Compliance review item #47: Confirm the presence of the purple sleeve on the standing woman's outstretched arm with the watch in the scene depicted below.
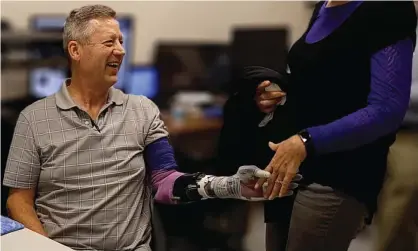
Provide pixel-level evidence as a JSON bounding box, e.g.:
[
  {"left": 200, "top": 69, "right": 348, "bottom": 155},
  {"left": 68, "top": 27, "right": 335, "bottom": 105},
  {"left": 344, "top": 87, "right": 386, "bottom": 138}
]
[{"left": 307, "top": 39, "right": 413, "bottom": 154}]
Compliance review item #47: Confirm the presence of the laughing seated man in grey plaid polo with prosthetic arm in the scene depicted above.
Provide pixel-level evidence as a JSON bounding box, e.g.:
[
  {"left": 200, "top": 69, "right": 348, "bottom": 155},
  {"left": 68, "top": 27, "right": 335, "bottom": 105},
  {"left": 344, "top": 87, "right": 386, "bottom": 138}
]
[{"left": 0, "top": 5, "right": 298, "bottom": 251}]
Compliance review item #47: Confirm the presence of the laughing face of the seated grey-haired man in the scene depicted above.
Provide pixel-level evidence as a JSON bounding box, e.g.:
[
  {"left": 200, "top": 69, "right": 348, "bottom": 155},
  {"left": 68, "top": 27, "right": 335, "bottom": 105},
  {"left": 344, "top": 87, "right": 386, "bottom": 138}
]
[{"left": 79, "top": 19, "right": 125, "bottom": 87}]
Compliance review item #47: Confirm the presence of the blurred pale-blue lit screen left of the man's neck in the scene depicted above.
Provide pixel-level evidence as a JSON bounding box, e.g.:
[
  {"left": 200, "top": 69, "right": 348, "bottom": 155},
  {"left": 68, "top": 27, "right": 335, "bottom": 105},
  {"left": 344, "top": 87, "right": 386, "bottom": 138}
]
[{"left": 29, "top": 67, "right": 67, "bottom": 99}]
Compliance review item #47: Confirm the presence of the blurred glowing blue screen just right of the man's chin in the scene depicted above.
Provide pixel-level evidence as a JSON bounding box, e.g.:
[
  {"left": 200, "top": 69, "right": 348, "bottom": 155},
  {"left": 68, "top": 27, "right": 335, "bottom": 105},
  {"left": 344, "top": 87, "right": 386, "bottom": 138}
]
[{"left": 125, "top": 65, "right": 158, "bottom": 99}]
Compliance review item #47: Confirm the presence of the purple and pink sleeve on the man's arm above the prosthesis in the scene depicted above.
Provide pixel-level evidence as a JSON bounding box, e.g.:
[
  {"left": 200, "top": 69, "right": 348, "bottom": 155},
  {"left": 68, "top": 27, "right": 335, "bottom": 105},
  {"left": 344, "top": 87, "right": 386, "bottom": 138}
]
[{"left": 145, "top": 138, "right": 183, "bottom": 204}]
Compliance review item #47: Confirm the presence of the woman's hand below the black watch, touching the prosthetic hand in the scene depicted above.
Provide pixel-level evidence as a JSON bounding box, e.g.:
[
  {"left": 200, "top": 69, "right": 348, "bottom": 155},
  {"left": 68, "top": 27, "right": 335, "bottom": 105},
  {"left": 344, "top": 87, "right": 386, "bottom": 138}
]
[{"left": 255, "top": 135, "right": 306, "bottom": 199}]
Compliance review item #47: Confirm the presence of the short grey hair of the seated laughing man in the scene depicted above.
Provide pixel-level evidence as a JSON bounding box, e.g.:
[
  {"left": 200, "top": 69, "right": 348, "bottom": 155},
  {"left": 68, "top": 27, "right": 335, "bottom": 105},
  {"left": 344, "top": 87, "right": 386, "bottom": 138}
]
[{"left": 62, "top": 4, "right": 116, "bottom": 54}]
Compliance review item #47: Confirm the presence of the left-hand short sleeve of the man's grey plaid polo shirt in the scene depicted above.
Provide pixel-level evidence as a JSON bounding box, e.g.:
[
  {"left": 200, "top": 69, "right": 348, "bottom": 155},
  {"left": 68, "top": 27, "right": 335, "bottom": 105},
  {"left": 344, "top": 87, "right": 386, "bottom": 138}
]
[{"left": 3, "top": 113, "right": 41, "bottom": 189}]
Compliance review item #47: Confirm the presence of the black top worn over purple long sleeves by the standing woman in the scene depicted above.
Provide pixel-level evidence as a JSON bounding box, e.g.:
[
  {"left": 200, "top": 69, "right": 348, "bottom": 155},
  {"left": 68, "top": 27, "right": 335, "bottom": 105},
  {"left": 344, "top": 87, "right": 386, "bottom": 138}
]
[{"left": 266, "top": 1, "right": 416, "bottom": 220}]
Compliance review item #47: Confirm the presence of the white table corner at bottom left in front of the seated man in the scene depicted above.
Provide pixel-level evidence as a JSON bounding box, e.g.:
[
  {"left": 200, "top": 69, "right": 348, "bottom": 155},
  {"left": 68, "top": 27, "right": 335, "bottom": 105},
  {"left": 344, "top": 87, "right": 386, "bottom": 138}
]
[{"left": 1, "top": 228, "right": 74, "bottom": 251}]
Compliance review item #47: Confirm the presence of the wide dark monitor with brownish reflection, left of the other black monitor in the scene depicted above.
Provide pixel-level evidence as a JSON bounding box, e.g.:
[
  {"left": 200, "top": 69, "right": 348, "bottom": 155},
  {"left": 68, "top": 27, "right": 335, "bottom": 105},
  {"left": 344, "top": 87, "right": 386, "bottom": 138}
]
[{"left": 154, "top": 42, "right": 230, "bottom": 106}]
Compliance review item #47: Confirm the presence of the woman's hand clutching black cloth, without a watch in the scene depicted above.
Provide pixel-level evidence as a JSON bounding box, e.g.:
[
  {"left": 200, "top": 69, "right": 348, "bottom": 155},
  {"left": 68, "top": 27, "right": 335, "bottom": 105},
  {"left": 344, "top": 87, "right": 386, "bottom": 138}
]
[{"left": 254, "top": 81, "right": 286, "bottom": 113}]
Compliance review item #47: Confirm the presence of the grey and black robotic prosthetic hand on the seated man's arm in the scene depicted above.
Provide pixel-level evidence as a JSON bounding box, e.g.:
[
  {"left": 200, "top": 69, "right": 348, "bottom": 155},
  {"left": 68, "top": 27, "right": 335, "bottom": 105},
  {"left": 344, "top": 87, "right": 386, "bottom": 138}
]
[{"left": 173, "top": 166, "right": 302, "bottom": 203}]
